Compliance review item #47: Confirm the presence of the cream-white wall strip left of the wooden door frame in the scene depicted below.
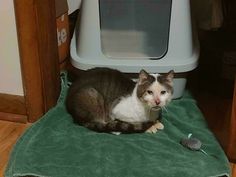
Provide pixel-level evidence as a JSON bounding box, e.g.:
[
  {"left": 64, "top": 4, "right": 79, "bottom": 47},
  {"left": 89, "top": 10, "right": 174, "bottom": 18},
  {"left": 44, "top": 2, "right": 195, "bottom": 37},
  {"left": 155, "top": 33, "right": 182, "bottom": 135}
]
[{"left": 0, "top": 0, "right": 24, "bottom": 95}]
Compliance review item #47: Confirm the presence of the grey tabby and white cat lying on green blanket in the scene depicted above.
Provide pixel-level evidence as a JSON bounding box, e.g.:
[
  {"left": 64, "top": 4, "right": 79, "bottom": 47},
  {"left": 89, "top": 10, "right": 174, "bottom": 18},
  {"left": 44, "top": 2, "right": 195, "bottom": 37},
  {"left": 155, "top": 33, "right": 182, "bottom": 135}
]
[{"left": 66, "top": 68, "right": 174, "bottom": 133}]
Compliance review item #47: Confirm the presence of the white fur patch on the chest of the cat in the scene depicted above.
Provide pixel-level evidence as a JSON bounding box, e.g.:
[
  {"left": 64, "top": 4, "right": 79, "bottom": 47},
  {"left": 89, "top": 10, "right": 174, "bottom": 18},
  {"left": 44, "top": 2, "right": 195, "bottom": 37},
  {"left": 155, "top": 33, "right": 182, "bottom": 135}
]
[{"left": 110, "top": 86, "right": 148, "bottom": 122}]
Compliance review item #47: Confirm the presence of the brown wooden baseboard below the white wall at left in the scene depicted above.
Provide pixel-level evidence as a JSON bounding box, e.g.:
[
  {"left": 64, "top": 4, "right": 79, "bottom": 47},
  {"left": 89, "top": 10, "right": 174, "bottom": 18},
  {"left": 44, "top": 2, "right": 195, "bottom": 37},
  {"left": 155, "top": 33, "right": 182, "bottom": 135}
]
[{"left": 0, "top": 93, "right": 27, "bottom": 122}]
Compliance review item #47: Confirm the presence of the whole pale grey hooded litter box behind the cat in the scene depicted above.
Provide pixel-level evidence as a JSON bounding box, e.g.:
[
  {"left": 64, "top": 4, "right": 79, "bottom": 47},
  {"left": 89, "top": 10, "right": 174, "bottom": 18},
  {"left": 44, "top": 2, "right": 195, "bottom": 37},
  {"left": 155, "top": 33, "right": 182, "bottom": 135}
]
[{"left": 70, "top": 0, "right": 199, "bottom": 98}]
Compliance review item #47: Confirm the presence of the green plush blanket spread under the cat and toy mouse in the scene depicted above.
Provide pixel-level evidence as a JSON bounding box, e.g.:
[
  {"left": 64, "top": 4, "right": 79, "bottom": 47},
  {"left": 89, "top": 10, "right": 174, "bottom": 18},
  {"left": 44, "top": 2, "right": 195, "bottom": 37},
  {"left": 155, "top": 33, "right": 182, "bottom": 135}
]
[{"left": 5, "top": 75, "right": 230, "bottom": 177}]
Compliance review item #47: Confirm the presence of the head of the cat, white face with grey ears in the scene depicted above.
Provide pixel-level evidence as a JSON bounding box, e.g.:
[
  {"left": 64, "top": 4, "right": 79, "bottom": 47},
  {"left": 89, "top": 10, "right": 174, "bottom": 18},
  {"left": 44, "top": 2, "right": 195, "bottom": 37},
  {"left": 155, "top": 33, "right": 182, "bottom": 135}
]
[{"left": 137, "top": 70, "right": 174, "bottom": 107}]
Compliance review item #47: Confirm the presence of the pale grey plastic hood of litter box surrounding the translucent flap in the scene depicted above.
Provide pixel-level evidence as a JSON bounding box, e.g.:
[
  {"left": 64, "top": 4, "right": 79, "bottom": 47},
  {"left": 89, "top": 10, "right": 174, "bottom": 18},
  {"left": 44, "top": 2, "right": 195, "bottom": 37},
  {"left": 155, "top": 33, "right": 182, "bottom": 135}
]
[{"left": 70, "top": 0, "right": 199, "bottom": 73}]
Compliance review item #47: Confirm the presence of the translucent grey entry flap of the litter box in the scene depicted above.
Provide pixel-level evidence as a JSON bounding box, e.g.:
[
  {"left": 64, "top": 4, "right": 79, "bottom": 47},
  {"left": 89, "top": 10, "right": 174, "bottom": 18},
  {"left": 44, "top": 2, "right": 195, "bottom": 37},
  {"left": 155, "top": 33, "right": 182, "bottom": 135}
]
[{"left": 99, "top": 0, "right": 172, "bottom": 59}]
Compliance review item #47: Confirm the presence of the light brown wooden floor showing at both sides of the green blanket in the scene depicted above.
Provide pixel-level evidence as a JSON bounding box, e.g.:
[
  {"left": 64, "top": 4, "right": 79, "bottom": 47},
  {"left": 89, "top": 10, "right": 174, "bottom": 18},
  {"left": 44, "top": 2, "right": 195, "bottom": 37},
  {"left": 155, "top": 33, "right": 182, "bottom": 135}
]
[{"left": 0, "top": 120, "right": 236, "bottom": 177}]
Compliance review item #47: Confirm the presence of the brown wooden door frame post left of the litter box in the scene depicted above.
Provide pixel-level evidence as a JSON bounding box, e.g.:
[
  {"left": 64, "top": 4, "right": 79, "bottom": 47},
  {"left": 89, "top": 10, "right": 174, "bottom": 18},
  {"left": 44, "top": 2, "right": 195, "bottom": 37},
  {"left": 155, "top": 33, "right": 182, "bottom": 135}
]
[{"left": 14, "top": 0, "right": 60, "bottom": 122}]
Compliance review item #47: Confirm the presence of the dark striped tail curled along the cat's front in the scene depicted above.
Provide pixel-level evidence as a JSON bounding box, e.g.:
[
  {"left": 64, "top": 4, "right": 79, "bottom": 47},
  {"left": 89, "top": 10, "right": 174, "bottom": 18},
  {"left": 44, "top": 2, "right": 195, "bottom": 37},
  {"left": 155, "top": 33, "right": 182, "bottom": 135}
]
[{"left": 83, "top": 120, "right": 155, "bottom": 134}]
